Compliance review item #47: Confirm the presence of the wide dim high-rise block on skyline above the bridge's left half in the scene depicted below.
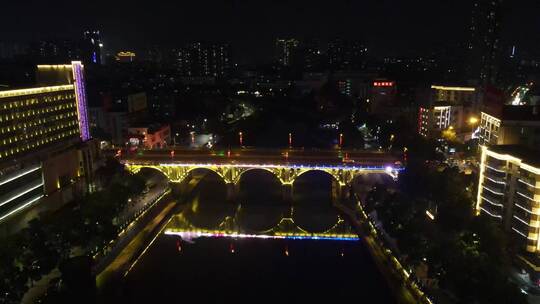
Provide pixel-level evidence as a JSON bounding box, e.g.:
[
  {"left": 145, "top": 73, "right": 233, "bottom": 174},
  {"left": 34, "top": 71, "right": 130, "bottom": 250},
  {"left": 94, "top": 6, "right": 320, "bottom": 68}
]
[{"left": 176, "top": 42, "right": 231, "bottom": 79}]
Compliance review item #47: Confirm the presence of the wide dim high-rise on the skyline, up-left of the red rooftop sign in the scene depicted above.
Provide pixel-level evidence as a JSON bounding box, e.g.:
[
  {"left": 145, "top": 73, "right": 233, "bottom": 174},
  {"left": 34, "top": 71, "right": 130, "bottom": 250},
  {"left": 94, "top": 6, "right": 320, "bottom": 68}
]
[{"left": 328, "top": 39, "right": 368, "bottom": 70}]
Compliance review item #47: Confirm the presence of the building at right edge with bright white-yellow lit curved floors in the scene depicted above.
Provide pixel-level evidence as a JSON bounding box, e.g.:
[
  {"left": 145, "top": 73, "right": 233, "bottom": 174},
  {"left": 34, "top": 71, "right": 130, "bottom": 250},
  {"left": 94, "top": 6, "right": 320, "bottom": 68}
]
[{"left": 476, "top": 145, "right": 540, "bottom": 281}]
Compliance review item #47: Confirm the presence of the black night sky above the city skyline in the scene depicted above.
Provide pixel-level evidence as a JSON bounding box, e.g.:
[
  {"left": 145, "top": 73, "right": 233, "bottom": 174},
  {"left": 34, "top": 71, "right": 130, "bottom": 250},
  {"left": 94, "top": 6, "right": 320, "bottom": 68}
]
[{"left": 0, "top": 0, "right": 540, "bottom": 60}]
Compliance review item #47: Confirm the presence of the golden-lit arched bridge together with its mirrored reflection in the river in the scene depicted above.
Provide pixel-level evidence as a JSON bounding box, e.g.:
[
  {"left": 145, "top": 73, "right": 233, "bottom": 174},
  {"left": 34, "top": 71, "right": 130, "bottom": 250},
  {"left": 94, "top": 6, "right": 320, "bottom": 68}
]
[{"left": 118, "top": 149, "right": 402, "bottom": 240}]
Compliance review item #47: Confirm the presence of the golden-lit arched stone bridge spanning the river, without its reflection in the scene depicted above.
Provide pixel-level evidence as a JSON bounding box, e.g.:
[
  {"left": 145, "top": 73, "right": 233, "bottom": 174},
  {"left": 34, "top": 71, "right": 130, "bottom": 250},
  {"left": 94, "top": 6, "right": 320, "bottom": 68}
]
[{"left": 118, "top": 149, "right": 402, "bottom": 187}]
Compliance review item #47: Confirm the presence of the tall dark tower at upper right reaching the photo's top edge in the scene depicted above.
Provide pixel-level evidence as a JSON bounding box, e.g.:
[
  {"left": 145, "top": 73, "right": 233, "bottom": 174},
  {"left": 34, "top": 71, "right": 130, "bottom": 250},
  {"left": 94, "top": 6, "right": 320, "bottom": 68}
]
[{"left": 468, "top": 0, "right": 502, "bottom": 84}]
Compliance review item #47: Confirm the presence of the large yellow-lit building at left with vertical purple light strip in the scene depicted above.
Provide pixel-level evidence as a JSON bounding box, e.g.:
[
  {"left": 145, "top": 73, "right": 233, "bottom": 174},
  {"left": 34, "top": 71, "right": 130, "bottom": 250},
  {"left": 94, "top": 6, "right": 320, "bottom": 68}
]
[{"left": 0, "top": 62, "right": 90, "bottom": 226}]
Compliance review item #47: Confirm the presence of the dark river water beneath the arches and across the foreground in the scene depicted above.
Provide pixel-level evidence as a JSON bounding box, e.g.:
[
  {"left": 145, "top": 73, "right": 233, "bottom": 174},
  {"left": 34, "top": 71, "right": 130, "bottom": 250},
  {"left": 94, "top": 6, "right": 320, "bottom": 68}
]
[{"left": 121, "top": 171, "right": 394, "bottom": 303}]
